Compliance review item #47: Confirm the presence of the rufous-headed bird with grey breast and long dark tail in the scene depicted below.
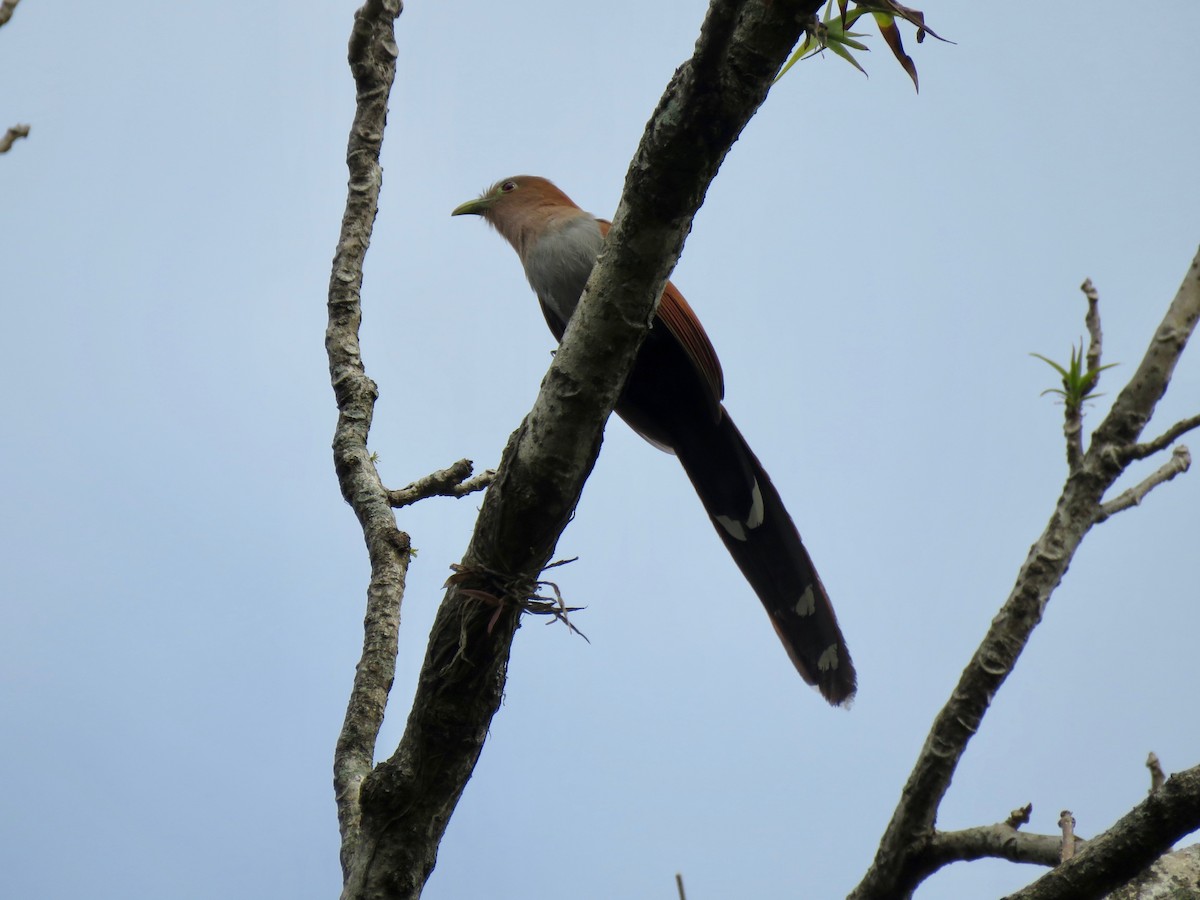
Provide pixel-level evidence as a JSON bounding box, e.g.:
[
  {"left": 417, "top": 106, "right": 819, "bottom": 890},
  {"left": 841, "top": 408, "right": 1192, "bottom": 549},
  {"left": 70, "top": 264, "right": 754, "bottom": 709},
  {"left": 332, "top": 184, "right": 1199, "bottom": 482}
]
[{"left": 451, "top": 175, "right": 857, "bottom": 706}]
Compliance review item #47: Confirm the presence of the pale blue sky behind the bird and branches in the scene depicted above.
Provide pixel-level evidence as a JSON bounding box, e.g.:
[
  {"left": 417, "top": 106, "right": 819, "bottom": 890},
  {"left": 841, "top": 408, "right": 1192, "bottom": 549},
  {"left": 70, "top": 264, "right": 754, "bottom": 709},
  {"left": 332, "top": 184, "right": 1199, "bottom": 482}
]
[{"left": 0, "top": 0, "right": 1200, "bottom": 900}]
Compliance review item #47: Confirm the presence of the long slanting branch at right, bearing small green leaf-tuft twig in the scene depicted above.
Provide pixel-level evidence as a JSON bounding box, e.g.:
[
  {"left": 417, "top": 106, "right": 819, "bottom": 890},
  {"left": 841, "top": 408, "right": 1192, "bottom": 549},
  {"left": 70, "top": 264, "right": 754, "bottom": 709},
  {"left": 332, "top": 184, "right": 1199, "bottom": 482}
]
[{"left": 851, "top": 253, "right": 1200, "bottom": 900}]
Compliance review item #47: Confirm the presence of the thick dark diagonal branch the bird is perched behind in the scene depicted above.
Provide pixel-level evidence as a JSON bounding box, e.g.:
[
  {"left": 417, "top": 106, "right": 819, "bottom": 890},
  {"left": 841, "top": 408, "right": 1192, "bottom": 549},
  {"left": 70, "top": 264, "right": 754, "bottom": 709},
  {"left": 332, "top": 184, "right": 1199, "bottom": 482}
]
[{"left": 343, "top": 0, "right": 821, "bottom": 898}]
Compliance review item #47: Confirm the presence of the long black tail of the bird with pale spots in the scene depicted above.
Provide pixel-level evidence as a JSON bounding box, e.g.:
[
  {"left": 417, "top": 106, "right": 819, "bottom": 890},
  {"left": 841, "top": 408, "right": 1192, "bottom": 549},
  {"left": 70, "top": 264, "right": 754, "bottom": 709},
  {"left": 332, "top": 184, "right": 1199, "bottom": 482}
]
[{"left": 674, "top": 410, "right": 857, "bottom": 706}]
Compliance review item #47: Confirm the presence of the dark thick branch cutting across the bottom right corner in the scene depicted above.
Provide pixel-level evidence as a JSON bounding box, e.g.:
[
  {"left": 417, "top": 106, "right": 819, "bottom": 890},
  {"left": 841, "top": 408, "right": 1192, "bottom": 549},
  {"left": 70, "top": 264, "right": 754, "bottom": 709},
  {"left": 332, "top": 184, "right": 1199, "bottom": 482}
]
[{"left": 1007, "top": 766, "right": 1200, "bottom": 900}]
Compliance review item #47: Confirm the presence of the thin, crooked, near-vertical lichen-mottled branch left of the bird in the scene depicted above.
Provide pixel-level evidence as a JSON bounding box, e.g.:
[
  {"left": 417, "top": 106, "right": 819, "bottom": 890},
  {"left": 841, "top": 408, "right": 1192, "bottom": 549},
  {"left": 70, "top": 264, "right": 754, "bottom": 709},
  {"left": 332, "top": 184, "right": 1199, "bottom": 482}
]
[{"left": 325, "top": 0, "right": 409, "bottom": 877}]
